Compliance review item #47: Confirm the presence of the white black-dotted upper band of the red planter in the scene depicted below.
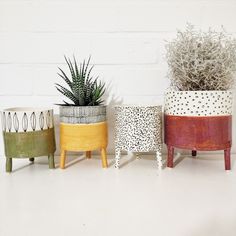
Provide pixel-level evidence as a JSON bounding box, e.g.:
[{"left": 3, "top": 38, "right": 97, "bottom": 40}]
[{"left": 165, "top": 91, "right": 233, "bottom": 116}]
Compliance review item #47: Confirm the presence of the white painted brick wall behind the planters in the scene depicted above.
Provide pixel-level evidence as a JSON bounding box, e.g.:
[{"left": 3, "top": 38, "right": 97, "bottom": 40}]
[{"left": 0, "top": 0, "right": 236, "bottom": 155}]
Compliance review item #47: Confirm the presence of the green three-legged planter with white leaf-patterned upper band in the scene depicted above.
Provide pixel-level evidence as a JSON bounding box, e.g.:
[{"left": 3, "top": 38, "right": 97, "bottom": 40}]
[{"left": 1, "top": 107, "right": 56, "bottom": 172}]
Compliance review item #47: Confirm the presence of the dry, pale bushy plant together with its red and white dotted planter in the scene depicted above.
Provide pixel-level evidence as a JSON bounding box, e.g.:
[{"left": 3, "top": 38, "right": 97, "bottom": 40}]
[{"left": 164, "top": 25, "right": 236, "bottom": 170}]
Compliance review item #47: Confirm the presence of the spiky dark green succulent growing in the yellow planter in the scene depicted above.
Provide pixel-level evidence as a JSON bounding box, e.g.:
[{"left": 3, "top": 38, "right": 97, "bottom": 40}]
[{"left": 55, "top": 57, "right": 105, "bottom": 106}]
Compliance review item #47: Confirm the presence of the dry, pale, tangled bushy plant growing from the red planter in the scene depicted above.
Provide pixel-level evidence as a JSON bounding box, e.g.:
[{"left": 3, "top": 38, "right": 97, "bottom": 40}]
[{"left": 166, "top": 24, "right": 236, "bottom": 91}]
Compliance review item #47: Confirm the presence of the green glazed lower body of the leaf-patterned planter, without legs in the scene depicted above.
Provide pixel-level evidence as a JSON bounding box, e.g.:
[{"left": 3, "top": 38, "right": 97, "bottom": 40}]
[{"left": 3, "top": 128, "right": 56, "bottom": 158}]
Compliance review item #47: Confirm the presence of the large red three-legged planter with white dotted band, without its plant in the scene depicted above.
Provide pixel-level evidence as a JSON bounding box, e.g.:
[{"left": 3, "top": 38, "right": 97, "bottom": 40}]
[{"left": 164, "top": 91, "right": 233, "bottom": 170}]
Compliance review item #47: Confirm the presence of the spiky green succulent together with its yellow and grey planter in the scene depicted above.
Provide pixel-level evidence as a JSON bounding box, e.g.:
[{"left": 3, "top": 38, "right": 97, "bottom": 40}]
[{"left": 56, "top": 57, "right": 107, "bottom": 168}]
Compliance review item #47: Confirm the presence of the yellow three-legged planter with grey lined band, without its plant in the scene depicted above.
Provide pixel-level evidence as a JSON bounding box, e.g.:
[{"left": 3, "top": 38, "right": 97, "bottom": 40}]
[{"left": 60, "top": 106, "right": 108, "bottom": 169}]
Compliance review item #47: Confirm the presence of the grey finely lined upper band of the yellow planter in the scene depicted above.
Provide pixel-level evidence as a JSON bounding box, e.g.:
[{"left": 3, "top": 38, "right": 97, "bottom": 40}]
[{"left": 59, "top": 106, "right": 106, "bottom": 124}]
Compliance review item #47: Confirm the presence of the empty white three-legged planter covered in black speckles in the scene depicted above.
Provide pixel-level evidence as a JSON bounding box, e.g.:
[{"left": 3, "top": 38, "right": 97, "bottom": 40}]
[{"left": 115, "top": 105, "right": 162, "bottom": 168}]
